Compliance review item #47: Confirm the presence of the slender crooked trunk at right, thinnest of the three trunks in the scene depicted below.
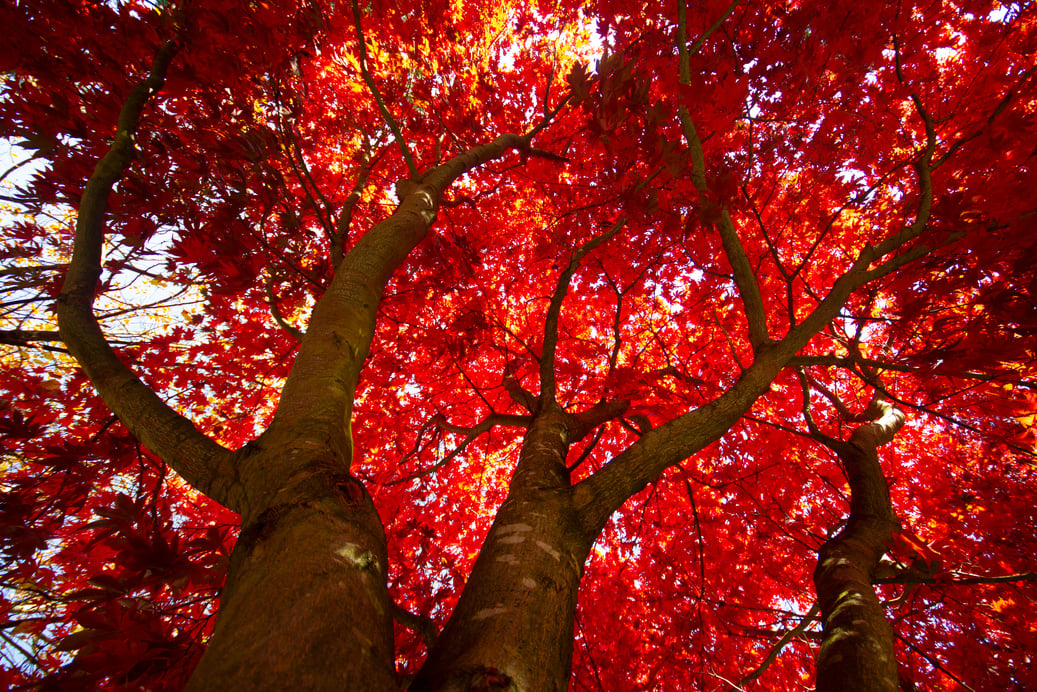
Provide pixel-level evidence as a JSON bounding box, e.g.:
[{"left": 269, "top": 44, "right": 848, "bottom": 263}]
[{"left": 814, "top": 403, "right": 903, "bottom": 692}]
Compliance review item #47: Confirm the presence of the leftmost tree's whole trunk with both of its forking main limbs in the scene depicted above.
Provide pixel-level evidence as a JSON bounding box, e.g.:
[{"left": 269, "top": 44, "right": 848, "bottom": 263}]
[{"left": 56, "top": 33, "right": 547, "bottom": 692}]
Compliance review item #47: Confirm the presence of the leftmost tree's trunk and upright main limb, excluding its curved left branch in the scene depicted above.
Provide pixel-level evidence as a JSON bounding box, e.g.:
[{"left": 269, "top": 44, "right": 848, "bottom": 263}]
[{"left": 188, "top": 135, "right": 535, "bottom": 692}]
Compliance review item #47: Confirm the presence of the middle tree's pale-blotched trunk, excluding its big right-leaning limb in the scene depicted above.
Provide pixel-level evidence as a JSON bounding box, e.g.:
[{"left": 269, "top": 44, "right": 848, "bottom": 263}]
[{"left": 410, "top": 409, "right": 593, "bottom": 692}]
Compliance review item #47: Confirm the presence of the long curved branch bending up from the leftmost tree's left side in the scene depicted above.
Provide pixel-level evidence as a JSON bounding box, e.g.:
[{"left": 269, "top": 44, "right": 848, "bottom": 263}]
[{"left": 55, "top": 40, "right": 241, "bottom": 508}]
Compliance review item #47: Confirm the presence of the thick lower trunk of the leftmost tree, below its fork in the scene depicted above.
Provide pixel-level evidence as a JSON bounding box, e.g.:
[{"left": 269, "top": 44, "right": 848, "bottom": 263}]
[{"left": 187, "top": 454, "right": 398, "bottom": 692}]
